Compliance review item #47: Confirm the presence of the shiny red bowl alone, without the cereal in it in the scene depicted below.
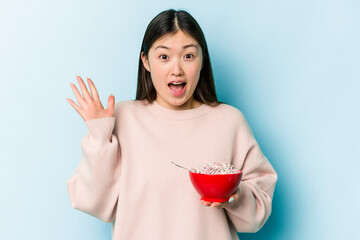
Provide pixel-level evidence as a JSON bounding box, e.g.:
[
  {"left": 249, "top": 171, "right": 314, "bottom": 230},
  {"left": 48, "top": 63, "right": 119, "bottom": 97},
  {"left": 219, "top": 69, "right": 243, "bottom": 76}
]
[{"left": 189, "top": 171, "right": 242, "bottom": 202}]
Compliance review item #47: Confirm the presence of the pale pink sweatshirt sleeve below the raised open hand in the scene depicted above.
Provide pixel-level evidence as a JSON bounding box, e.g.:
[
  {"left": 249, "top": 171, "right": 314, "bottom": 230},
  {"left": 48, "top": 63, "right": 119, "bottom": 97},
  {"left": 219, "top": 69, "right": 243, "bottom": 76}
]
[{"left": 66, "top": 117, "right": 121, "bottom": 222}]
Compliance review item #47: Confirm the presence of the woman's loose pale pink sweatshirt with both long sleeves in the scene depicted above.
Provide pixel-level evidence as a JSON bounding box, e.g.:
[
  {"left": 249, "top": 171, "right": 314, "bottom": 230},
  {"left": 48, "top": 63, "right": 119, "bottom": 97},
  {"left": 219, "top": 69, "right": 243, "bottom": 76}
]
[{"left": 67, "top": 101, "right": 277, "bottom": 240}]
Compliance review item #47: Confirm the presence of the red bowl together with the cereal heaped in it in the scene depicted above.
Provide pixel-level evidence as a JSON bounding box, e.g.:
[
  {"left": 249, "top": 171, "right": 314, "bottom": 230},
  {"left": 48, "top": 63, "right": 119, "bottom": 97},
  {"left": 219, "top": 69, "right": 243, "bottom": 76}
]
[{"left": 189, "top": 162, "right": 242, "bottom": 202}]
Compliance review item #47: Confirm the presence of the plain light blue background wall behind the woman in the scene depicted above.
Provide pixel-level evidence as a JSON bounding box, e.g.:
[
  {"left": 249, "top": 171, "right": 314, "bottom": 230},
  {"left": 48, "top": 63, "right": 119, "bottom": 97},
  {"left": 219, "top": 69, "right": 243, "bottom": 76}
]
[{"left": 0, "top": 0, "right": 360, "bottom": 240}]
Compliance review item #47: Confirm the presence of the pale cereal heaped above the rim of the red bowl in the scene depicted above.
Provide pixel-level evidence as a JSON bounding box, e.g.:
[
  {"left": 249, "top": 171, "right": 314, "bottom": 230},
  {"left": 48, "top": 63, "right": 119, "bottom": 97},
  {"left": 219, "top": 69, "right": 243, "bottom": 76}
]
[{"left": 190, "top": 162, "right": 240, "bottom": 175}]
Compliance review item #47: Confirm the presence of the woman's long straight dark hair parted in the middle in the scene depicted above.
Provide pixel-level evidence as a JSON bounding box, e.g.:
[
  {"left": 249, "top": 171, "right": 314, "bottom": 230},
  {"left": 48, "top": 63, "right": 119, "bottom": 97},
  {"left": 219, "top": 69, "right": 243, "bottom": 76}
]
[{"left": 136, "top": 9, "right": 220, "bottom": 105}]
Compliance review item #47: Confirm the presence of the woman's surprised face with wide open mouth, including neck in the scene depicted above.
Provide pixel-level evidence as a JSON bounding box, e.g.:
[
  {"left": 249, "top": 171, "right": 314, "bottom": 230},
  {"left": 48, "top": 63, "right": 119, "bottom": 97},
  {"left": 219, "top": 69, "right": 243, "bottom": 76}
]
[{"left": 141, "top": 30, "right": 203, "bottom": 110}]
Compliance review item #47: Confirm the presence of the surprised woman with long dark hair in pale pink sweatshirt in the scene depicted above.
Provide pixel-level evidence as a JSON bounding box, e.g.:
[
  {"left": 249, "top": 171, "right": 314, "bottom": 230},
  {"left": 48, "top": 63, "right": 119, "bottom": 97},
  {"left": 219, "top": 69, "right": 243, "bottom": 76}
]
[{"left": 67, "top": 9, "right": 277, "bottom": 240}]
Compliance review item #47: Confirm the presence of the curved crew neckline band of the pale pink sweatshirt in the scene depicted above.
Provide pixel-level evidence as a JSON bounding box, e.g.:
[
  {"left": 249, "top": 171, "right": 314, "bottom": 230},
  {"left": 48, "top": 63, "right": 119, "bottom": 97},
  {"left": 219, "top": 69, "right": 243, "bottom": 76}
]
[{"left": 143, "top": 100, "right": 211, "bottom": 120}]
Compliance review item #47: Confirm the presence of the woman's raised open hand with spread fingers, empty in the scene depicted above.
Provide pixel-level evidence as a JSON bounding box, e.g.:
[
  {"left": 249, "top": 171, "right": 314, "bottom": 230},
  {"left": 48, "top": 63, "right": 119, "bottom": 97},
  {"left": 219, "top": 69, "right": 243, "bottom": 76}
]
[{"left": 67, "top": 76, "right": 115, "bottom": 121}]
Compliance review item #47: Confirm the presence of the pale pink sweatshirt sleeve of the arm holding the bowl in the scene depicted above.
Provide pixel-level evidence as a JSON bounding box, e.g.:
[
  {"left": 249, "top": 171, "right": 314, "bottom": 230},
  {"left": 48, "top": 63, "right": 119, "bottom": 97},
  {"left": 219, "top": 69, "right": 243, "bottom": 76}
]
[{"left": 225, "top": 114, "right": 277, "bottom": 232}]
